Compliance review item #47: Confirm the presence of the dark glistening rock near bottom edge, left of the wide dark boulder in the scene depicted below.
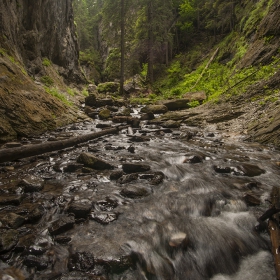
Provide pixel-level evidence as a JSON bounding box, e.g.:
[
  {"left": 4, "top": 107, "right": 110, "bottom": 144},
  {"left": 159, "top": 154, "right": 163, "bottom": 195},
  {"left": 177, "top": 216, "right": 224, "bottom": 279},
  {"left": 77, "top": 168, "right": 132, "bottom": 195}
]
[{"left": 68, "top": 252, "right": 95, "bottom": 271}]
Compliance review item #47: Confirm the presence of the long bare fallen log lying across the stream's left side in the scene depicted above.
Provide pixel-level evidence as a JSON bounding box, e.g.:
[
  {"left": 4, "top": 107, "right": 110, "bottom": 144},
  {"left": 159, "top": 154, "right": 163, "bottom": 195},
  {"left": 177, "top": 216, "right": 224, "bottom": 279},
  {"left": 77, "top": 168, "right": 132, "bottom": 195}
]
[{"left": 0, "top": 126, "right": 127, "bottom": 163}]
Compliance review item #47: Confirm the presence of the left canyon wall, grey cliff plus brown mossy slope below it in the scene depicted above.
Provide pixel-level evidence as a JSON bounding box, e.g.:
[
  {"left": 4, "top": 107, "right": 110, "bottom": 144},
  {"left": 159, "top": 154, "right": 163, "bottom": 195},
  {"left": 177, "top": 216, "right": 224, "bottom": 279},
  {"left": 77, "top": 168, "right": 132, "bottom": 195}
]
[{"left": 0, "top": 0, "right": 84, "bottom": 142}]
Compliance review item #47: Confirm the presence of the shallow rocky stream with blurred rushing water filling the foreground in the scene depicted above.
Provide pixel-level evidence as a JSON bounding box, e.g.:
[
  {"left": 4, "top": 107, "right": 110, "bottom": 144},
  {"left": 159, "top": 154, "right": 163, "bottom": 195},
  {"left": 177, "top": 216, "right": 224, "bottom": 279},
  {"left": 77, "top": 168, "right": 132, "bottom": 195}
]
[{"left": 0, "top": 106, "right": 280, "bottom": 280}]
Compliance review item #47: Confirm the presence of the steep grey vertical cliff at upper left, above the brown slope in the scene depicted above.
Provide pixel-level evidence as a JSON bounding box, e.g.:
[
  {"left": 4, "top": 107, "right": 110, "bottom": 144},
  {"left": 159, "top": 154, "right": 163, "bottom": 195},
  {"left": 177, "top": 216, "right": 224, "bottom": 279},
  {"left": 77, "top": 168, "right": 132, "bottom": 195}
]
[{"left": 0, "top": 0, "right": 83, "bottom": 82}]
